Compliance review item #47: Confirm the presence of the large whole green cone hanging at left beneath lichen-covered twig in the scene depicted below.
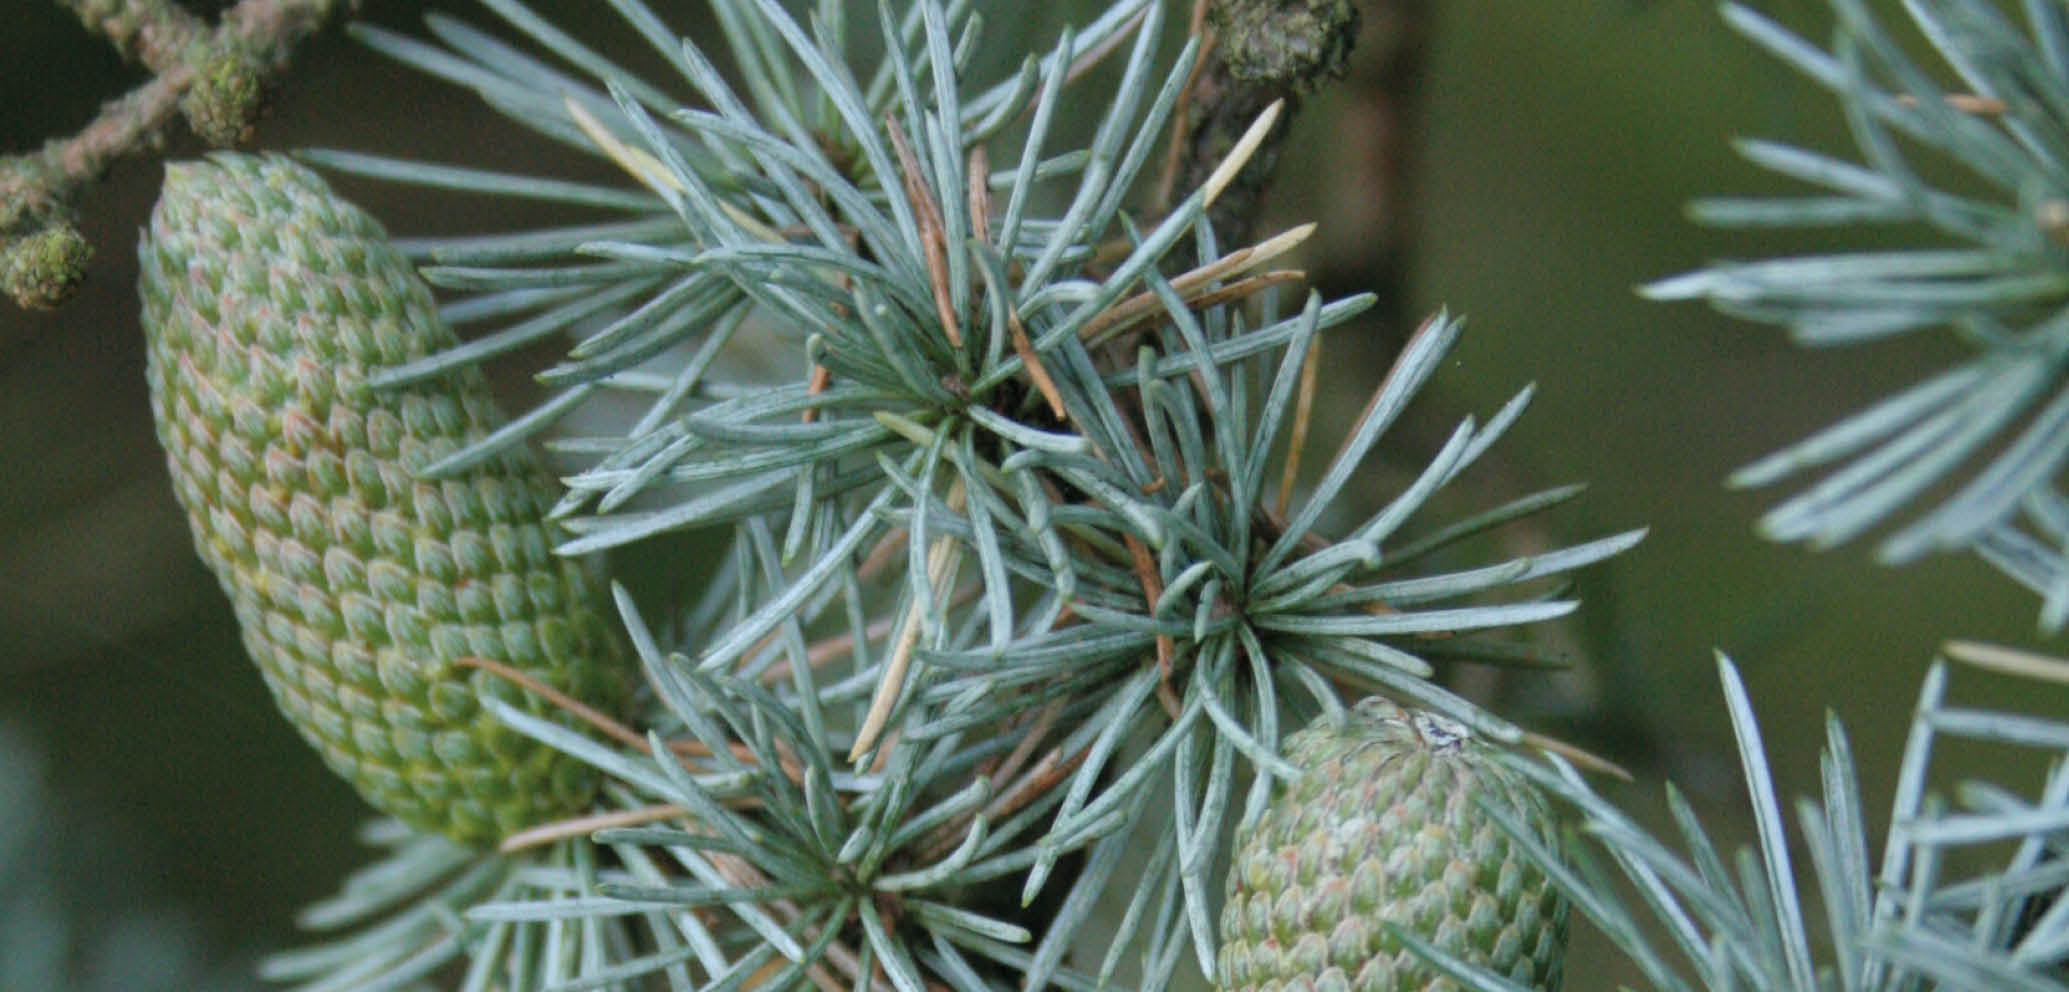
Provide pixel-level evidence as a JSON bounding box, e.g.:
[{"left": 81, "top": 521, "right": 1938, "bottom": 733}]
[{"left": 139, "top": 153, "right": 629, "bottom": 845}]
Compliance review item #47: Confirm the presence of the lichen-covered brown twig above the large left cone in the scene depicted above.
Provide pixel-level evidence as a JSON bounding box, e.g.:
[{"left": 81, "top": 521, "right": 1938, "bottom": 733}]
[{"left": 0, "top": 0, "right": 356, "bottom": 309}]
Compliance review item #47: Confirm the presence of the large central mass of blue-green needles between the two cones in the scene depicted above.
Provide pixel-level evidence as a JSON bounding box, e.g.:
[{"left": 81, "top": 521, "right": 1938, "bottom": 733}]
[{"left": 133, "top": 0, "right": 1641, "bottom": 992}]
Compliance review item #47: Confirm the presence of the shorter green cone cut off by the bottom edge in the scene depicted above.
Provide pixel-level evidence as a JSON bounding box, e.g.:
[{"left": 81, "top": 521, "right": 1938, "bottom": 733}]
[{"left": 1219, "top": 698, "right": 1566, "bottom": 992}]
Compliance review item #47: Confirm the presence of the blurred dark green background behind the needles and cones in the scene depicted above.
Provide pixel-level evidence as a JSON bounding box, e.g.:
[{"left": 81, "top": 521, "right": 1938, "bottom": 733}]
[{"left": 0, "top": 0, "right": 2065, "bottom": 988}]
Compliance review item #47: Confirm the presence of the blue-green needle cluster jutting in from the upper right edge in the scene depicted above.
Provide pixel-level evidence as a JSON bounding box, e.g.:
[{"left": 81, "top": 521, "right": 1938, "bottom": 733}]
[{"left": 1645, "top": 0, "right": 2069, "bottom": 632}]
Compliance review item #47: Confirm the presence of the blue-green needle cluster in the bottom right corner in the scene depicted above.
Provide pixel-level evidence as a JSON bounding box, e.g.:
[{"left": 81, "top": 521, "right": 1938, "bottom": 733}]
[{"left": 1405, "top": 644, "right": 2069, "bottom": 992}]
